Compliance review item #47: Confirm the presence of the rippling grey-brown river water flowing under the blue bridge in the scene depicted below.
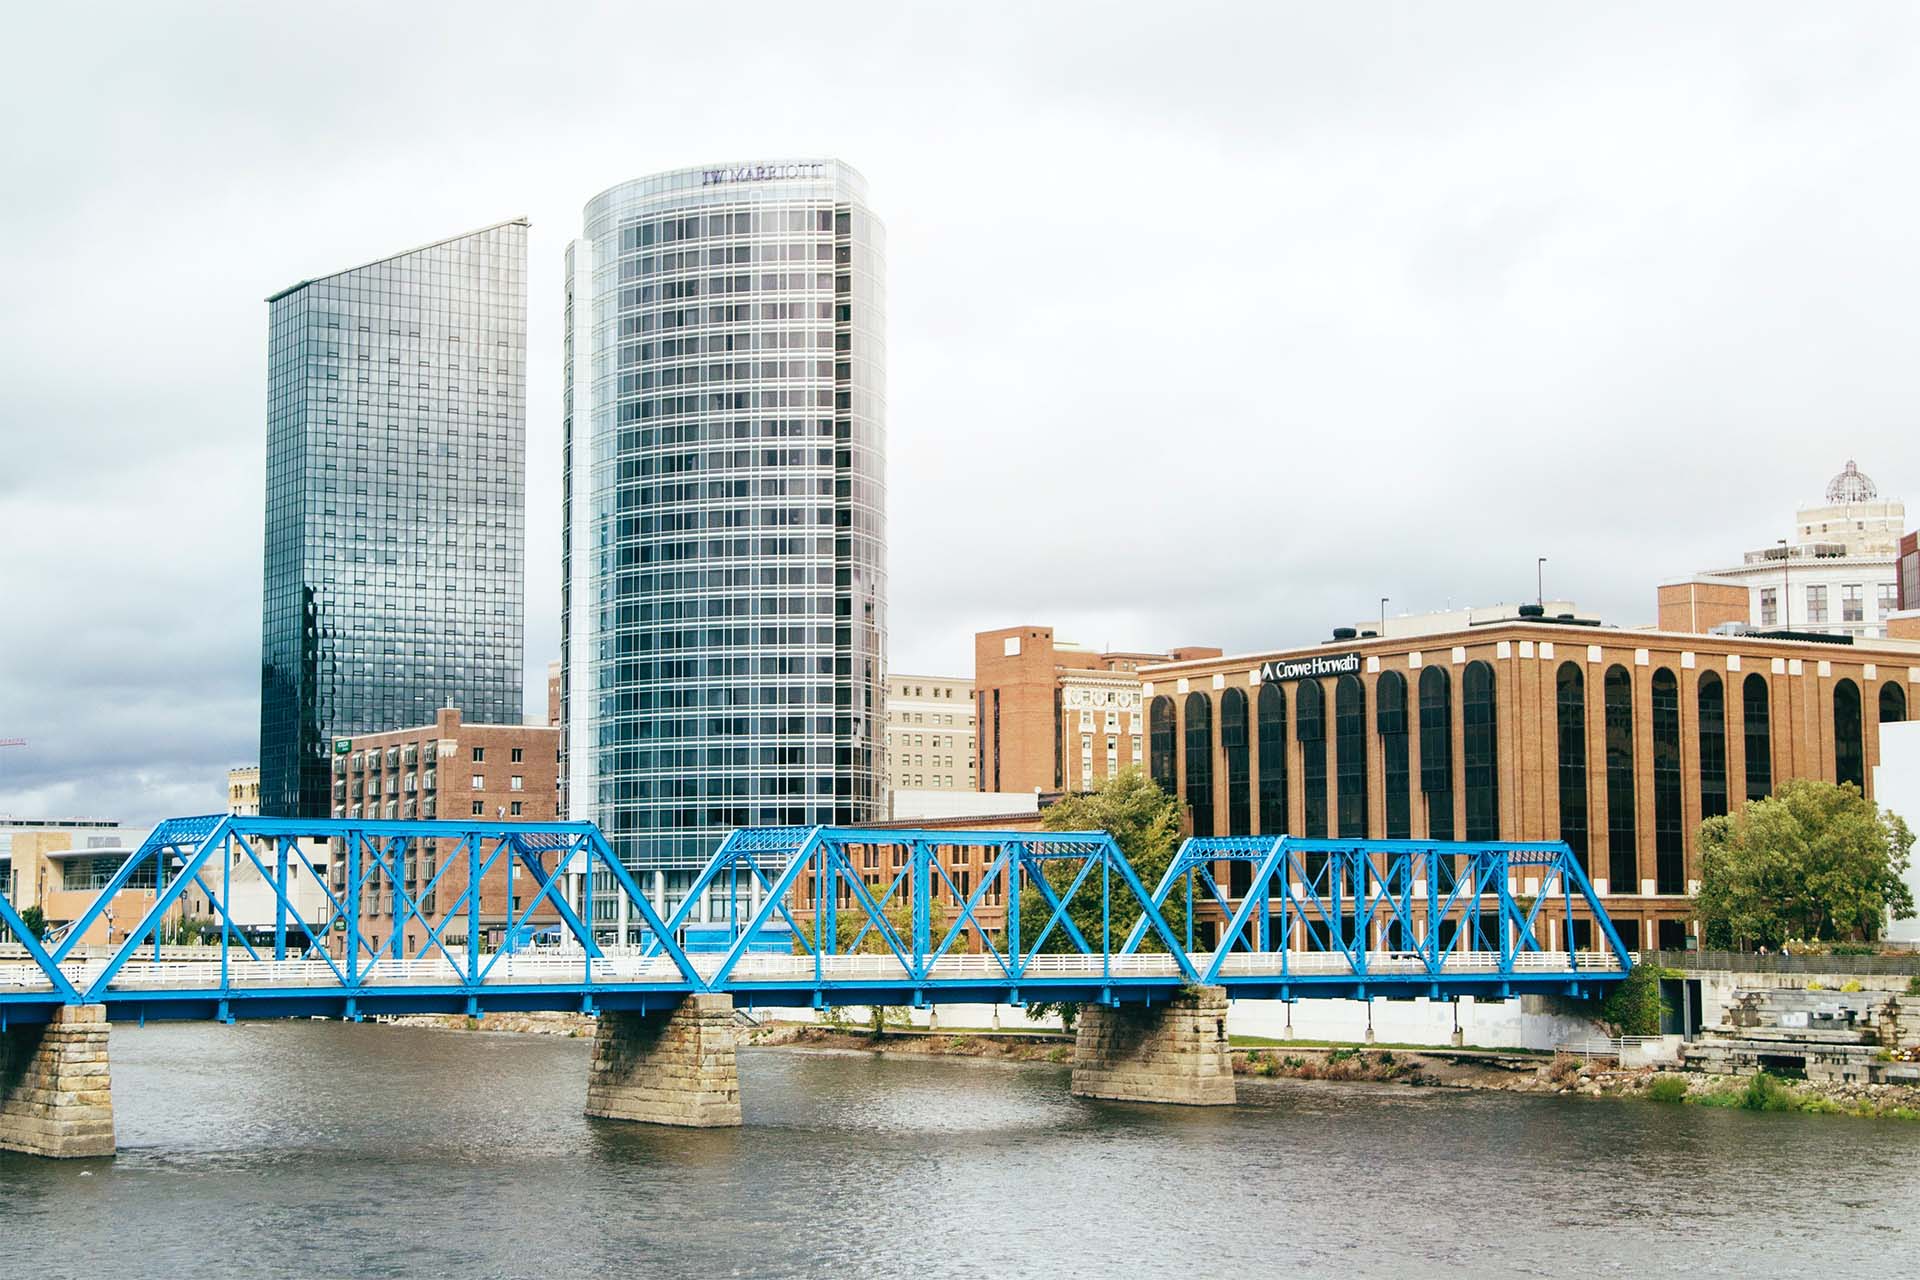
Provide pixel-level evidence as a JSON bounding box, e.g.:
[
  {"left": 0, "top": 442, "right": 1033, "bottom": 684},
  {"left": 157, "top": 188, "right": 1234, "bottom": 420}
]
[{"left": 0, "top": 1023, "right": 1920, "bottom": 1280}]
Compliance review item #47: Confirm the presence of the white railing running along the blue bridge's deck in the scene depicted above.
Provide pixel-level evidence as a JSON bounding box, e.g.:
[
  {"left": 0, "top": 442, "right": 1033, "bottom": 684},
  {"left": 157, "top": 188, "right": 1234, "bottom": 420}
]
[{"left": 0, "top": 952, "right": 1622, "bottom": 992}]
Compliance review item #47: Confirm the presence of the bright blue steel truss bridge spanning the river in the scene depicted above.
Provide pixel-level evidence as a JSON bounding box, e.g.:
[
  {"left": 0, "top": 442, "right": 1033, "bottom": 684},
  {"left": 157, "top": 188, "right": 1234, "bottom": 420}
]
[{"left": 0, "top": 816, "right": 1632, "bottom": 1031}]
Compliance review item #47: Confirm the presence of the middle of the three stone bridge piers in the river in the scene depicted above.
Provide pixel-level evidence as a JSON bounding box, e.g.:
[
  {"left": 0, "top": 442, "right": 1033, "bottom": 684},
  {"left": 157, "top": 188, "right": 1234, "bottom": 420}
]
[{"left": 588, "top": 996, "right": 739, "bottom": 1128}]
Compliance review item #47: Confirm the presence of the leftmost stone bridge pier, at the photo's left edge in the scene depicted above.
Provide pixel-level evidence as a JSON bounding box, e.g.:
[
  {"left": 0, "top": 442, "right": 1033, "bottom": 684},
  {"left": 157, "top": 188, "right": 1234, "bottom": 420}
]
[{"left": 0, "top": 1004, "right": 113, "bottom": 1159}]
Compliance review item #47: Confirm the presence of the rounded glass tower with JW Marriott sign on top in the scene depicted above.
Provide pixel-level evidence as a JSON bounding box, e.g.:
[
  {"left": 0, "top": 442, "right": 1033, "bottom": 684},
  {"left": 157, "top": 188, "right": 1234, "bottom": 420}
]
[{"left": 561, "top": 159, "right": 887, "bottom": 921}]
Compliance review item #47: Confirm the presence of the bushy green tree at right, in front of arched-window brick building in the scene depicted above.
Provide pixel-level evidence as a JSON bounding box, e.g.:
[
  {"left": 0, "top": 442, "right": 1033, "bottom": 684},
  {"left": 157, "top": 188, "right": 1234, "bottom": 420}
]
[{"left": 1695, "top": 777, "right": 1914, "bottom": 948}]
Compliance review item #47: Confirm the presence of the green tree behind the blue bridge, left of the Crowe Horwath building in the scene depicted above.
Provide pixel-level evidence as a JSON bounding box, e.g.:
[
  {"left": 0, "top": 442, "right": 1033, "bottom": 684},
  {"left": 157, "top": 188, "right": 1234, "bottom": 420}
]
[{"left": 1020, "top": 770, "right": 1187, "bottom": 1031}]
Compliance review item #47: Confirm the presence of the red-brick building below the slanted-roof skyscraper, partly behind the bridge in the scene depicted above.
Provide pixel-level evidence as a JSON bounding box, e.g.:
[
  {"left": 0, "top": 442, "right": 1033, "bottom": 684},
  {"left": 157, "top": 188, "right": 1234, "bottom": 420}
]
[{"left": 328, "top": 708, "right": 561, "bottom": 952}]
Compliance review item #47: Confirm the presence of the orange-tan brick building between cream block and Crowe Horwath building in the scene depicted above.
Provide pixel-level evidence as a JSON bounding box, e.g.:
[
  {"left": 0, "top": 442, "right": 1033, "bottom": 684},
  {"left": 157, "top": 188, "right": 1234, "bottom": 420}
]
[{"left": 973, "top": 626, "right": 1219, "bottom": 791}]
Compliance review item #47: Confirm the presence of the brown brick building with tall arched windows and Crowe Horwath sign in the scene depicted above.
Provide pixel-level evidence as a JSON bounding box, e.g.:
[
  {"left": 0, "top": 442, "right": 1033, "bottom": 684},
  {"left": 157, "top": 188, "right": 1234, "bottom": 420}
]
[{"left": 1140, "top": 616, "right": 1920, "bottom": 946}]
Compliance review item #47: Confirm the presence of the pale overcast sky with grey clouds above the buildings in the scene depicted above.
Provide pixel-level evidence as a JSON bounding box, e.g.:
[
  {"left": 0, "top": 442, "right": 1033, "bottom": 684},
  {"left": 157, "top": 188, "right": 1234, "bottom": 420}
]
[{"left": 0, "top": 2, "right": 1920, "bottom": 825}]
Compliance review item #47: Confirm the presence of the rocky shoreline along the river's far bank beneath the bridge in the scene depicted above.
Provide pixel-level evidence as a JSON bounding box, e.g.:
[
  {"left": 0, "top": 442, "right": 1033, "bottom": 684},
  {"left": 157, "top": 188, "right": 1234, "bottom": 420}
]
[{"left": 374, "top": 1013, "right": 1920, "bottom": 1121}]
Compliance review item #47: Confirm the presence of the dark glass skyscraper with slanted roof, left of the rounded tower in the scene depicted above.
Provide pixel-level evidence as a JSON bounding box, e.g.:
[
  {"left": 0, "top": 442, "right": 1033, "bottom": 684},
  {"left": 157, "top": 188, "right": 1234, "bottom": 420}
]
[{"left": 259, "top": 219, "right": 526, "bottom": 818}]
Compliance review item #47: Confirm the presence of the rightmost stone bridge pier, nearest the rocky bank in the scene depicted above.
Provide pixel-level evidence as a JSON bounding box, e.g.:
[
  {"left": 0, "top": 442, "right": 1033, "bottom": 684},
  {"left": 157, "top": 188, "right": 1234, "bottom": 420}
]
[{"left": 1073, "top": 986, "right": 1236, "bottom": 1107}]
